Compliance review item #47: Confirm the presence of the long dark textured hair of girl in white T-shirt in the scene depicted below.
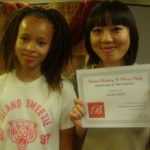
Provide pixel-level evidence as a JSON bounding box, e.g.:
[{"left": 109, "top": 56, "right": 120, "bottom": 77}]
[{"left": 0, "top": 6, "right": 72, "bottom": 89}]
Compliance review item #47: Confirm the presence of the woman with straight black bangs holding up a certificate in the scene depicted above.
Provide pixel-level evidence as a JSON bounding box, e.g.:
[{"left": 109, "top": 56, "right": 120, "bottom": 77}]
[{"left": 70, "top": 1, "right": 149, "bottom": 150}]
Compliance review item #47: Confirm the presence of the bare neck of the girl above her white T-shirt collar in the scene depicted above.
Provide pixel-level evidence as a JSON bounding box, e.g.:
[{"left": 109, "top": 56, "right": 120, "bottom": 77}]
[{"left": 16, "top": 69, "right": 41, "bottom": 82}]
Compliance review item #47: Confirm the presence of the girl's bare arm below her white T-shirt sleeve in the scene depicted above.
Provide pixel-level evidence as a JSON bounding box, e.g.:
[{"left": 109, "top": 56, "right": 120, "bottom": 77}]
[{"left": 60, "top": 128, "right": 74, "bottom": 150}]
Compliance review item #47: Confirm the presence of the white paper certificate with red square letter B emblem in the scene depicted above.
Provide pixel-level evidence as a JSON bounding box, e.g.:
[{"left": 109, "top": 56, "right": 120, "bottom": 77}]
[{"left": 76, "top": 64, "right": 150, "bottom": 128}]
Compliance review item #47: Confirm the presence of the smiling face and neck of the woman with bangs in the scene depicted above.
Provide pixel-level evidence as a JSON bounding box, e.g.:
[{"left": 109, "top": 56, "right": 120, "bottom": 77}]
[{"left": 90, "top": 25, "right": 130, "bottom": 67}]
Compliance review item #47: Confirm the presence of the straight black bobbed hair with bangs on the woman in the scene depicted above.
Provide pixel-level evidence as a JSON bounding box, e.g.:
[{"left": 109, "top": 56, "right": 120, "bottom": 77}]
[{"left": 85, "top": 1, "right": 139, "bottom": 65}]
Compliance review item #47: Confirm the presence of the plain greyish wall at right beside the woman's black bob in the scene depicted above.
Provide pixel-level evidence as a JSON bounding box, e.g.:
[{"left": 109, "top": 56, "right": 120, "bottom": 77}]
[{"left": 129, "top": 6, "right": 150, "bottom": 63}]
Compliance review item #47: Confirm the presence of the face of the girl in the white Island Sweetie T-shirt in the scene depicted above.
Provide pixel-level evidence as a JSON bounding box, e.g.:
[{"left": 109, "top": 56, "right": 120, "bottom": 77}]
[{"left": 15, "top": 16, "right": 53, "bottom": 71}]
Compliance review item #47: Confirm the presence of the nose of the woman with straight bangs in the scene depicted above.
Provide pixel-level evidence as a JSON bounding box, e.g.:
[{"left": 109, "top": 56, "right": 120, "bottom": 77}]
[{"left": 101, "top": 31, "right": 113, "bottom": 42}]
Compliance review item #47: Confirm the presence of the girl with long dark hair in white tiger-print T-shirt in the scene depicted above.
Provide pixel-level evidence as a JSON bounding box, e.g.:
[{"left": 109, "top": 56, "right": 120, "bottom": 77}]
[{"left": 0, "top": 6, "right": 75, "bottom": 150}]
